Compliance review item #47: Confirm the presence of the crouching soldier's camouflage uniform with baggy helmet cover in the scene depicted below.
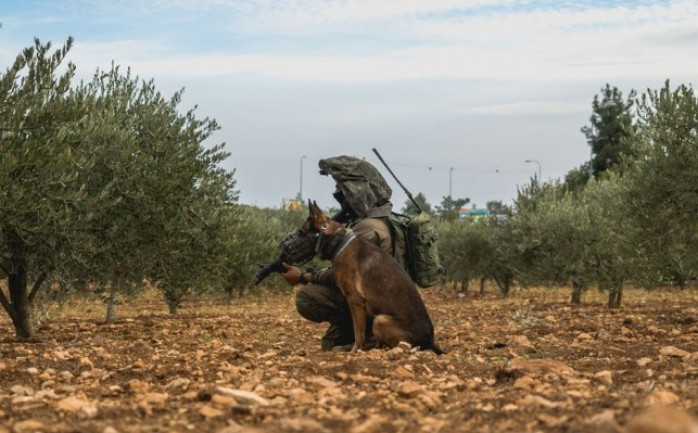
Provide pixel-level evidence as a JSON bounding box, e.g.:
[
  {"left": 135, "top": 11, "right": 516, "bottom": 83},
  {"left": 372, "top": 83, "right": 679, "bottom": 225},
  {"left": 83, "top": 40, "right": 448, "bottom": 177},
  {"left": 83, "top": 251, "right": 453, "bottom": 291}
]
[{"left": 296, "top": 156, "right": 393, "bottom": 350}]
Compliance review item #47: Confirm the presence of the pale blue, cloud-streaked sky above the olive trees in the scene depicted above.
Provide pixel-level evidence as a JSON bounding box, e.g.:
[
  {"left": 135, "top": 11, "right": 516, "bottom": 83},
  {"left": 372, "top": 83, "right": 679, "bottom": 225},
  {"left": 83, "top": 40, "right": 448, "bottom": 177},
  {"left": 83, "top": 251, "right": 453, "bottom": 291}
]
[{"left": 0, "top": 0, "right": 698, "bottom": 210}]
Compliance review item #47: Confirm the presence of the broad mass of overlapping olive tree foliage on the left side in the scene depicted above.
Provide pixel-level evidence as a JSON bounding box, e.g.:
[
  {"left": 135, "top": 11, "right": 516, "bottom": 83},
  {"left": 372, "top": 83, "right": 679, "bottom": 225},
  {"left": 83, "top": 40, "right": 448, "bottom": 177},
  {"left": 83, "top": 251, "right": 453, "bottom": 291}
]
[{"left": 0, "top": 40, "right": 237, "bottom": 330}]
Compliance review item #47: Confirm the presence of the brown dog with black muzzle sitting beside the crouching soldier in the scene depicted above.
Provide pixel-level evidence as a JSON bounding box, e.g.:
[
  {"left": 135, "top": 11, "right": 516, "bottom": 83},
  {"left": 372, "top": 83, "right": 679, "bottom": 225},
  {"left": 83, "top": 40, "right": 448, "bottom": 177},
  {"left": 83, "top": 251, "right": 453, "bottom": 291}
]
[{"left": 300, "top": 200, "right": 444, "bottom": 355}]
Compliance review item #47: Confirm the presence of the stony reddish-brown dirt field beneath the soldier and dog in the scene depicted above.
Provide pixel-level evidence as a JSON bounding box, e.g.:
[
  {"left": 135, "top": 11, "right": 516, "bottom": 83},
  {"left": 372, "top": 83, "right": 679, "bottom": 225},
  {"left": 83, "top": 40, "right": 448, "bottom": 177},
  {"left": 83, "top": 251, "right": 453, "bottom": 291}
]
[{"left": 0, "top": 288, "right": 698, "bottom": 433}]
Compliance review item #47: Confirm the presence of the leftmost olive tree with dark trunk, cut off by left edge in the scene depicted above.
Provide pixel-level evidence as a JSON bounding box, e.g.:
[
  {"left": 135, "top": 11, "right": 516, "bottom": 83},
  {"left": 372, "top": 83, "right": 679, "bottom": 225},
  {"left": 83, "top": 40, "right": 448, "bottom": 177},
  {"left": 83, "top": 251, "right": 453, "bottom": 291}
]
[{"left": 0, "top": 39, "right": 92, "bottom": 339}]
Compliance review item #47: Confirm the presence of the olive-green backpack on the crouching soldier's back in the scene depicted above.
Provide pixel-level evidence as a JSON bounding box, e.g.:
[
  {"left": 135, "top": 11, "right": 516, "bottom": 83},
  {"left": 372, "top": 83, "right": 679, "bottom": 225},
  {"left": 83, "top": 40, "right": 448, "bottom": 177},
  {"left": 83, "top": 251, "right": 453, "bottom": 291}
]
[{"left": 387, "top": 212, "right": 443, "bottom": 287}]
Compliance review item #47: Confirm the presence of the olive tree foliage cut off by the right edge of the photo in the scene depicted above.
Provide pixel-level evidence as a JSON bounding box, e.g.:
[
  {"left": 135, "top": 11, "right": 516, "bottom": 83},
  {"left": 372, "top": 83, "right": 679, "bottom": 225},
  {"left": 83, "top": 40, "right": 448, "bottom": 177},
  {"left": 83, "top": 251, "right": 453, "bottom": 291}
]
[{"left": 624, "top": 81, "right": 698, "bottom": 285}]
